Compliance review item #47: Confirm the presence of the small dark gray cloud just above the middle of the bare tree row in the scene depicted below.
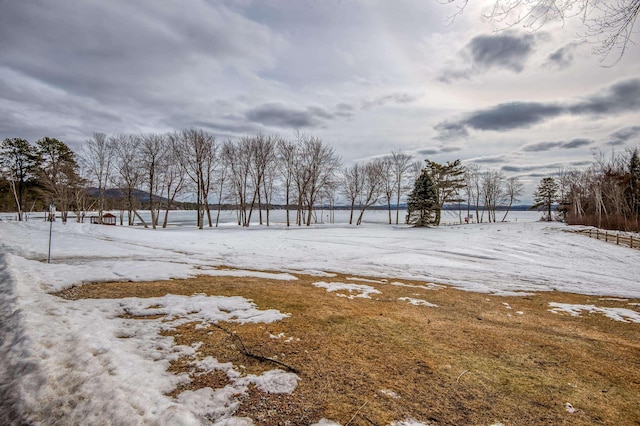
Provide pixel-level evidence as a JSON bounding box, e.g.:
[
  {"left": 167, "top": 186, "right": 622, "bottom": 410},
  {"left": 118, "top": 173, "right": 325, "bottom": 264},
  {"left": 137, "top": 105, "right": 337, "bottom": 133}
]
[{"left": 245, "top": 103, "right": 333, "bottom": 129}]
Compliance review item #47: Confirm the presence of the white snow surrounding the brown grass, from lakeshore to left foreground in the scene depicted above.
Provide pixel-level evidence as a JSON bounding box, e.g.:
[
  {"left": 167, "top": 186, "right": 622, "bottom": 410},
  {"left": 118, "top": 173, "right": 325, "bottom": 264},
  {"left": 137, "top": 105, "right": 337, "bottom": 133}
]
[{"left": 0, "top": 211, "right": 640, "bottom": 425}]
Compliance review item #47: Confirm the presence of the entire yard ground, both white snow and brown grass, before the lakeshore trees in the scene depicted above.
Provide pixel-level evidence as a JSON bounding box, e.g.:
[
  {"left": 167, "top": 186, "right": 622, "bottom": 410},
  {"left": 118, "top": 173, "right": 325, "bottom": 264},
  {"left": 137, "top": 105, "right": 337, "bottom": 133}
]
[{"left": 0, "top": 221, "right": 640, "bottom": 424}]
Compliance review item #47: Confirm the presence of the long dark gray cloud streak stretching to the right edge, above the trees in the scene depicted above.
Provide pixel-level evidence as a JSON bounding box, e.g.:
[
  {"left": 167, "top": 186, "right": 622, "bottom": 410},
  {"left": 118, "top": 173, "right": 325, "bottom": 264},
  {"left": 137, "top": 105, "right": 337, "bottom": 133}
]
[{"left": 434, "top": 78, "right": 640, "bottom": 140}]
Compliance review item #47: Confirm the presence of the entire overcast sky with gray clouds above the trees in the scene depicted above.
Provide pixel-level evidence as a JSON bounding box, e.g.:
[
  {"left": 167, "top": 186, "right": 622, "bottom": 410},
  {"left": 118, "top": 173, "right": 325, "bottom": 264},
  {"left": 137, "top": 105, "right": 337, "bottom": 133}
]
[{"left": 0, "top": 0, "right": 640, "bottom": 201}]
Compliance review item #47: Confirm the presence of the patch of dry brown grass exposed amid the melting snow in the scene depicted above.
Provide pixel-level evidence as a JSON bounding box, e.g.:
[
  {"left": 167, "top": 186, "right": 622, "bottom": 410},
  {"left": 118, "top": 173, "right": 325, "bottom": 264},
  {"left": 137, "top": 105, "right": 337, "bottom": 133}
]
[{"left": 56, "top": 275, "right": 640, "bottom": 425}]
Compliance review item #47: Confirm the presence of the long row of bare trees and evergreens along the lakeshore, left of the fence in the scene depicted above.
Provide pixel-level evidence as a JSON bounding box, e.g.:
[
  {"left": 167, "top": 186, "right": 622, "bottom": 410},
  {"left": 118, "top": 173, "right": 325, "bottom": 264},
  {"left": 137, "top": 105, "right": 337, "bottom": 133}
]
[{"left": 0, "top": 129, "right": 522, "bottom": 228}]
